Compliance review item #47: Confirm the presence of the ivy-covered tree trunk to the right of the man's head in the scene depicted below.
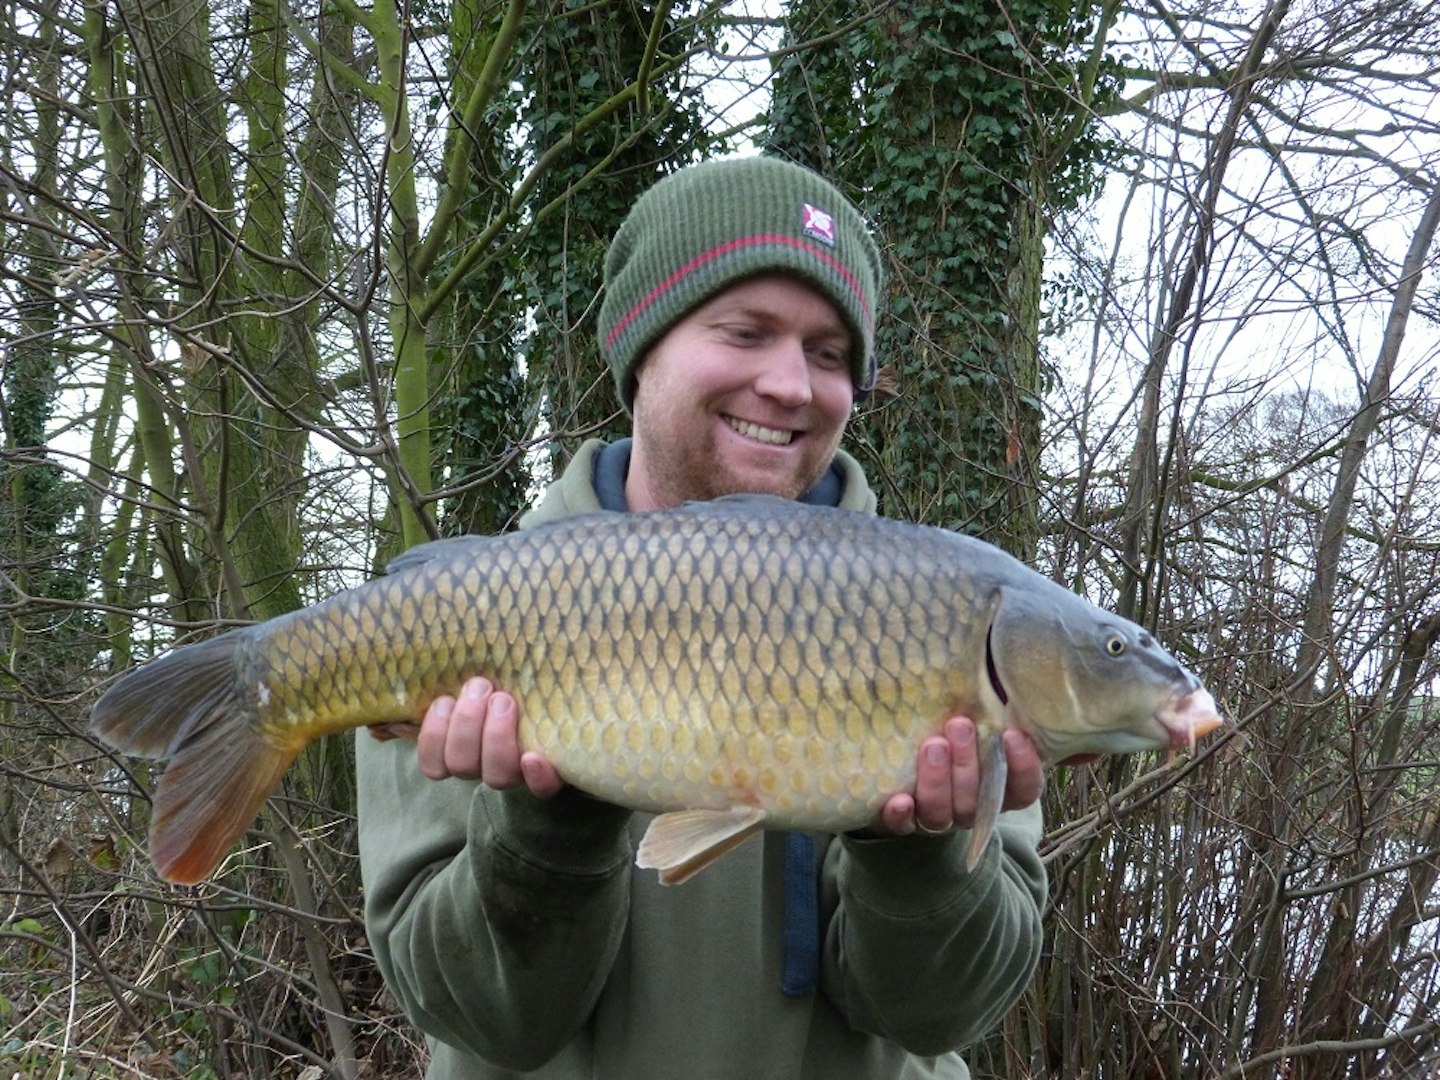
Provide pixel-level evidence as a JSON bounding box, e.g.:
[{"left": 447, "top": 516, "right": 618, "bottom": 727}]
[{"left": 770, "top": 0, "right": 1117, "bottom": 553}]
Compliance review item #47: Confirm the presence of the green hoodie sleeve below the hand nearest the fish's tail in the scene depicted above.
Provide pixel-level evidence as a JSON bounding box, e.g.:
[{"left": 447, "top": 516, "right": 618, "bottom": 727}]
[{"left": 356, "top": 732, "right": 632, "bottom": 1070}]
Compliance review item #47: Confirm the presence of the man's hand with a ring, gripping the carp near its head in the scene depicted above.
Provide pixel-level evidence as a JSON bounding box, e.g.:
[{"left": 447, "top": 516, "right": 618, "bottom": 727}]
[{"left": 876, "top": 716, "right": 1045, "bottom": 837}]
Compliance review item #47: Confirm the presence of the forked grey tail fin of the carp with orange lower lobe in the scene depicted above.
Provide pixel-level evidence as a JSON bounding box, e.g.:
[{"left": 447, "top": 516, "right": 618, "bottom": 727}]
[{"left": 91, "top": 631, "right": 301, "bottom": 886}]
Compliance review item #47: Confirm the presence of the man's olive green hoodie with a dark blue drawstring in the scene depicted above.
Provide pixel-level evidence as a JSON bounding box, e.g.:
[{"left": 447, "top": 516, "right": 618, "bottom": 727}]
[{"left": 356, "top": 442, "right": 1045, "bottom": 1080}]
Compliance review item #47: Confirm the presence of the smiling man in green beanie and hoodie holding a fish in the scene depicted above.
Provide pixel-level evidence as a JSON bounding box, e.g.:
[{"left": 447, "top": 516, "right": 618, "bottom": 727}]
[{"left": 357, "top": 158, "right": 1045, "bottom": 1080}]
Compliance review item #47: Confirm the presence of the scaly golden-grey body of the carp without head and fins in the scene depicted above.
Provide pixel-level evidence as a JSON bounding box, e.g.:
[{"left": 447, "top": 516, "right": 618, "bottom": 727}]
[{"left": 256, "top": 514, "right": 979, "bottom": 829}]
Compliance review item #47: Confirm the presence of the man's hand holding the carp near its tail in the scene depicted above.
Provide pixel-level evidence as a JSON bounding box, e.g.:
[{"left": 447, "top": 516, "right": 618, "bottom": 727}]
[{"left": 415, "top": 678, "right": 564, "bottom": 799}]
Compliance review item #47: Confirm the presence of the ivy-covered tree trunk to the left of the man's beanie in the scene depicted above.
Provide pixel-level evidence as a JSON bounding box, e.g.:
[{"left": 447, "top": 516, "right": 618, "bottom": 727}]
[{"left": 431, "top": 0, "right": 714, "bottom": 531}]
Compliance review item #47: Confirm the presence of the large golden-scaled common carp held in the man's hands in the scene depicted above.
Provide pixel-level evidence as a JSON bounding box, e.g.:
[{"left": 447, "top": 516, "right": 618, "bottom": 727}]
[{"left": 91, "top": 495, "right": 1221, "bottom": 884}]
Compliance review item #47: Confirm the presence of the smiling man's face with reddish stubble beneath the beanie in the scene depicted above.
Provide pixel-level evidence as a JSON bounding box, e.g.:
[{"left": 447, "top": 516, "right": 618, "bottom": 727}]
[{"left": 625, "top": 274, "right": 855, "bottom": 510}]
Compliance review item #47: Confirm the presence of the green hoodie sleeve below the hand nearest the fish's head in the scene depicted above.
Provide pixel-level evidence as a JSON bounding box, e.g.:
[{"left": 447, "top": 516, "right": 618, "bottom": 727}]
[{"left": 821, "top": 804, "right": 1047, "bottom": 1056}]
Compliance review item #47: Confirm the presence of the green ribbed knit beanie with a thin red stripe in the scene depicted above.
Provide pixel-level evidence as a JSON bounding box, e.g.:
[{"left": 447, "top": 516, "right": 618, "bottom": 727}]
[{"left": 599, "top": 157, "right": 881, "bottom": 409}]
